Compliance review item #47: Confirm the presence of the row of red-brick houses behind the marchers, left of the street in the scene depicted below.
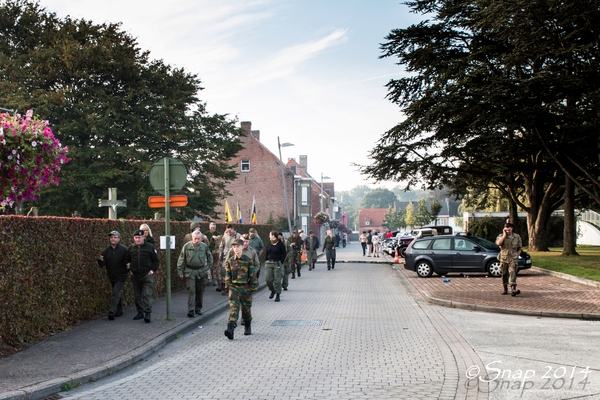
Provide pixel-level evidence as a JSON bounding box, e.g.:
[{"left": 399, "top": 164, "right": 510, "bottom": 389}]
[{"left": 216, "top": 122, "right": 333, "bottom": 234}]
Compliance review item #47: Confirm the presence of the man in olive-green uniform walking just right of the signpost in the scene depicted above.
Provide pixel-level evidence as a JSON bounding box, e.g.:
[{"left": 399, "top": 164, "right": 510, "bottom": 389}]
[{"left": 177, "top": 231, "right": 213, "bottom": 318}]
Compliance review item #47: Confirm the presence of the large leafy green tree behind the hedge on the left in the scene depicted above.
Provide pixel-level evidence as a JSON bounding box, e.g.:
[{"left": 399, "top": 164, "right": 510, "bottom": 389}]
[{"left": 0, "top": 0, "right": 243, "bottom": 219}]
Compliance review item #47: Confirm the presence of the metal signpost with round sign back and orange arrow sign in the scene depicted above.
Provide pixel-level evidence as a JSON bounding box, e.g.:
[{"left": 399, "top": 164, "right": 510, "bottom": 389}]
[{"left": 148, "top": 157, "right": 187, "bottom": 320}]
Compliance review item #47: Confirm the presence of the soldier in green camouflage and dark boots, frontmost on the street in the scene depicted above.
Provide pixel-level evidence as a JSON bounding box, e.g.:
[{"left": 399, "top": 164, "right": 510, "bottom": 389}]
[{"left": 225, "top": 239, "right": 258, "bottom": 340}]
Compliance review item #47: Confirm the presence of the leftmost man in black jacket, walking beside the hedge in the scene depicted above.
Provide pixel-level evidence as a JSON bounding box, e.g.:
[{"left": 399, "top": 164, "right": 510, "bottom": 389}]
[{"left": 98, "top": 231, "right": 129, "bottom": 321}]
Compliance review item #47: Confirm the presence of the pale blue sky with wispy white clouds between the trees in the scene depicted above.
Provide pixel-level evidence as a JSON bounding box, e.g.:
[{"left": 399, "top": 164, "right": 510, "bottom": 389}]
[{"left": 40, "top": 0, "right": 420, "bottom": 190}]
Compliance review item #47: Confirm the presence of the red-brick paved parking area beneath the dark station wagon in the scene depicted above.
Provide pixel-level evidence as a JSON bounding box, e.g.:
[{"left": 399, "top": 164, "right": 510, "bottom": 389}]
[{"left": 398, "top": 264, "right": 600, "bottom": 318}]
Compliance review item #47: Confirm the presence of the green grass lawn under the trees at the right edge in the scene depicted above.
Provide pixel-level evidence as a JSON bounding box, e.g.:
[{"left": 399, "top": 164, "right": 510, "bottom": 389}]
[{"left": 525, "top": 246, "right": 600, "bottom": 282}]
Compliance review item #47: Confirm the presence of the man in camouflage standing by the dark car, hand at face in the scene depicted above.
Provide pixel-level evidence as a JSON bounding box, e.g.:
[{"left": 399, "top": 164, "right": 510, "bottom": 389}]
[{"left": 496, "top": 222, "right": 523, "bottom": 296}]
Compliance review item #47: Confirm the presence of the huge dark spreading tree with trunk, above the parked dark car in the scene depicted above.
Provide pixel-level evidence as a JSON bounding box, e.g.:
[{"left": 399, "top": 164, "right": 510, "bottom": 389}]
[{"left": 363, "top": 0, "right": 600, "bottom": 250}]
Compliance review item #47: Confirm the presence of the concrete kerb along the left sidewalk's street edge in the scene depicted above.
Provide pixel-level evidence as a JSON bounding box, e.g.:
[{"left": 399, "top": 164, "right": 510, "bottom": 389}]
[{"left": 0, "top": 282, "right": 267, "bottom": 400}]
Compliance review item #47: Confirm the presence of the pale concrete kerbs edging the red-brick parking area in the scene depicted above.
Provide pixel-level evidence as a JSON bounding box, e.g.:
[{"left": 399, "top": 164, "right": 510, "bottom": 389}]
[{"left": 384, "top": 255, "right": 600, "bottom": 321}]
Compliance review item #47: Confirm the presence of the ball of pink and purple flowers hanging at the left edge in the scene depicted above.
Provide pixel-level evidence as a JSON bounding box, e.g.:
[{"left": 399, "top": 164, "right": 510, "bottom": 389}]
[{"left": 0, "top": 110, "right": 69, "bottom": 209}]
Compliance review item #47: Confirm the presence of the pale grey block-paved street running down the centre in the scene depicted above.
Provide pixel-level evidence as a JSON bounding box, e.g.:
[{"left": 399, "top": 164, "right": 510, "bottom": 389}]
[{"left": 61, "top": 255, "right": 488, "bottom": 399}]
